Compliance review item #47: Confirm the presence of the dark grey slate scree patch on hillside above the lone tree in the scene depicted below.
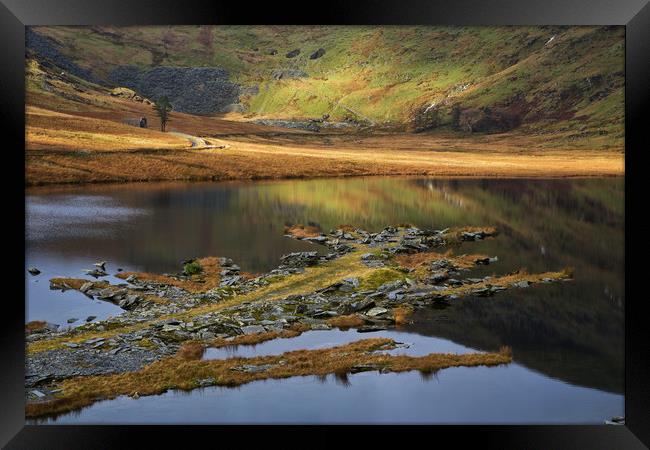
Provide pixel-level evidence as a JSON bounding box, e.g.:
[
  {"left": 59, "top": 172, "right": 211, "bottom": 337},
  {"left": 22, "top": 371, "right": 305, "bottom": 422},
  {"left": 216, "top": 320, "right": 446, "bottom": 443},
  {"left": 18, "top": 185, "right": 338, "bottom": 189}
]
[{"left": 109, "top": 66, "right": 240, "bottom": 114}]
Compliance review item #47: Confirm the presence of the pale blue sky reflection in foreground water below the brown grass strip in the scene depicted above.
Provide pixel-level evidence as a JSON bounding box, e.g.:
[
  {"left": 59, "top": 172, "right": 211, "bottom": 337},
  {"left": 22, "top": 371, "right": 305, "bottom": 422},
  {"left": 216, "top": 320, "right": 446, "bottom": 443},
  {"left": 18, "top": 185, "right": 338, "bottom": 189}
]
[{"left": 36, "top": 364, "right": 623, "bottom": 424}]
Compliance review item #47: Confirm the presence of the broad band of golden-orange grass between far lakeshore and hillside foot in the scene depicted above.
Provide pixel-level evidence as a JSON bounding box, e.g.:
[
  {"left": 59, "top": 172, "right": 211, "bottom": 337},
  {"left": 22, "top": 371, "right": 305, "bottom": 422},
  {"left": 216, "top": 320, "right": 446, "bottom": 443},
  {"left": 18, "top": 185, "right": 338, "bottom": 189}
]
[{"left": 26, "top": 107, "right": 625, "bottom": 185}]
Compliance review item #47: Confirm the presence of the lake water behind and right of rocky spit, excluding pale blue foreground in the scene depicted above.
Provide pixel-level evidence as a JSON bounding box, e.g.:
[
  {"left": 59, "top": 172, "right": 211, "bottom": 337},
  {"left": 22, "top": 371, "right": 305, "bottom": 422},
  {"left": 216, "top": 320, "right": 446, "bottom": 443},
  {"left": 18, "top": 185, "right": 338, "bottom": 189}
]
[{"left": 26, "top": 178, "right": 624, "bottom": 408}]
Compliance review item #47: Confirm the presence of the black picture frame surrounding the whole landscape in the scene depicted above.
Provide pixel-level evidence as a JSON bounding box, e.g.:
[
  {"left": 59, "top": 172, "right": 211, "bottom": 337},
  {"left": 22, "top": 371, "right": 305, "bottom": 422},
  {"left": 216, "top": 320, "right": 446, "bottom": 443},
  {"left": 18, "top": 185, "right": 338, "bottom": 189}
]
[{"left": 0, "top": 0, "right": 650, "bottom": 450}]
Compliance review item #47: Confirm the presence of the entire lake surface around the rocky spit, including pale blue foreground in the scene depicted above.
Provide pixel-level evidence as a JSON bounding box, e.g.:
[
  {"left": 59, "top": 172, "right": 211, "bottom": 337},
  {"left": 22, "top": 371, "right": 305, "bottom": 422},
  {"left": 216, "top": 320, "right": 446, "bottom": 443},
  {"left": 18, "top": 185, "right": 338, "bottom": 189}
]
[{"left": 26, "top": 178, "right": 624, "bottom": 423}]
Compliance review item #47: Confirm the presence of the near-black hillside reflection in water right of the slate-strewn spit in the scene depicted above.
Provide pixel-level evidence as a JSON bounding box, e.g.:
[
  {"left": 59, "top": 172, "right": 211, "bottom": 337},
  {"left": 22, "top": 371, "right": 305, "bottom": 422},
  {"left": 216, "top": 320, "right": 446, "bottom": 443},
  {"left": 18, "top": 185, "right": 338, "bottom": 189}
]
[{"left": 409, "top": 282, "right": 624, "bottom": 393}]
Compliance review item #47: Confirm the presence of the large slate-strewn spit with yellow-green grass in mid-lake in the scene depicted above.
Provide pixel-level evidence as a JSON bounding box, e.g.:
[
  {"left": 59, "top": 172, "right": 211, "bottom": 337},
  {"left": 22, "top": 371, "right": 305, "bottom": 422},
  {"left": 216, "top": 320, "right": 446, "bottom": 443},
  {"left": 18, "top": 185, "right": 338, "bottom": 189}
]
[{"left": 25, "top": 226, "right": 571, "bottom": 416}]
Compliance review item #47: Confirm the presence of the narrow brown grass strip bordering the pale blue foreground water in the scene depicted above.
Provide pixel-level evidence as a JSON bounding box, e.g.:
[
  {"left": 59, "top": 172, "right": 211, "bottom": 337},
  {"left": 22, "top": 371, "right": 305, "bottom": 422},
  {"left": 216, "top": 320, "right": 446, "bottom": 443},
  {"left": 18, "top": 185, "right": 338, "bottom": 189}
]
[{"left": 25, "top": 338, "right": 512, "bottom": 417}]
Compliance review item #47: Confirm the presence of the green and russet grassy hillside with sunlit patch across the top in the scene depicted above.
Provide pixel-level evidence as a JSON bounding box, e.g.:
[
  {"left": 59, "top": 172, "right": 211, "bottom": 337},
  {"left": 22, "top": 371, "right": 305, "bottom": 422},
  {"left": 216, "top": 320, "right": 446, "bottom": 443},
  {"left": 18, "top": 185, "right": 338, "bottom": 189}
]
[{"left": 34, "top": 26, "right": 624, "bottom": 141}]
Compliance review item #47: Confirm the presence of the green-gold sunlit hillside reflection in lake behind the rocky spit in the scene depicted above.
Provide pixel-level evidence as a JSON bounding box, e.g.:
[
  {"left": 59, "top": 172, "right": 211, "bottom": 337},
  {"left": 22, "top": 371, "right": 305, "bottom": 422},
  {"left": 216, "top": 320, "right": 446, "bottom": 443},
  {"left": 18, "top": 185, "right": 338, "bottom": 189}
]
[{"left": 239, "top": 178, "right": 624, "bottom": 296}]
